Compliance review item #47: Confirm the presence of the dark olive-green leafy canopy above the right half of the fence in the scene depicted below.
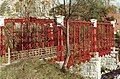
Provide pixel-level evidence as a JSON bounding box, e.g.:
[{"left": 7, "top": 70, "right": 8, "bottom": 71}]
[{"left": 50, "top": 0, "right": 116, "bottom": 21}]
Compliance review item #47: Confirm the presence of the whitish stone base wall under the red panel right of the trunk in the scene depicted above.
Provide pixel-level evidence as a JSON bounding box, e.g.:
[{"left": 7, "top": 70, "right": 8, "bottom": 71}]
[{"left": 80, "top": 52, "right": 101, "bottom": 79}]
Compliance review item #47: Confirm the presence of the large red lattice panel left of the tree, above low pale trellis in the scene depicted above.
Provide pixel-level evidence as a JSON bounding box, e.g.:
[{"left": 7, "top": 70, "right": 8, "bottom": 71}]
[{"left": 5, "top": 18, "right": 57, "bottom": 51}]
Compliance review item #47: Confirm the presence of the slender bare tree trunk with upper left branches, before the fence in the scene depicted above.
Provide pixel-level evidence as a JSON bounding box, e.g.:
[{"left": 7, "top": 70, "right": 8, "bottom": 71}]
[{"left": 50, "top": 0, "right": 72, "bottom": 72}]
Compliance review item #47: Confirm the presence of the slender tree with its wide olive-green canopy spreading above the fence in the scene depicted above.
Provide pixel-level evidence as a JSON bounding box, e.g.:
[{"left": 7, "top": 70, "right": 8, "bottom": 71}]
[{"left": 50, "top": 0, "right": 117, "bottom": 71}]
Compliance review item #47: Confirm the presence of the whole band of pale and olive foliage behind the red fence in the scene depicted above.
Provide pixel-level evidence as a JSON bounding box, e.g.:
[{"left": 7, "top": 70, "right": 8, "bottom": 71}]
[{"left": 0, "top": 0, "right": 117, "bottom": 21}]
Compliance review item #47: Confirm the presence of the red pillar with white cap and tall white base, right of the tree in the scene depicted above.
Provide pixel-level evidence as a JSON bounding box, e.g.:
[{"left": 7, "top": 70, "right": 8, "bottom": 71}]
[{"left": 91, "top": 19, "right": 101, "bottom": 79}]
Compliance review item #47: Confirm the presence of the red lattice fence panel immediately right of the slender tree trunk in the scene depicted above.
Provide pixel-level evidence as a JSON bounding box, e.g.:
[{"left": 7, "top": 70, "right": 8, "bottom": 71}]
[{"left": 68, "top": 21, "right": 94, "bottom": 67}]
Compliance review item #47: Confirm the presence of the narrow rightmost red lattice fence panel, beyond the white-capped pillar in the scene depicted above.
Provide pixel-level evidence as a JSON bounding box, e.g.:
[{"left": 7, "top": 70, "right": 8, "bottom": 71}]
[{"left": 97, "top": 23, "right": 114, "bottom": 56}]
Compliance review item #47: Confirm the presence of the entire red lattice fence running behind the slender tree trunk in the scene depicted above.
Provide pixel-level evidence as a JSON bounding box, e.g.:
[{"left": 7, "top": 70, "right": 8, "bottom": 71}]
[{"left": 0, "top": 18, "right": 114, "bottom": 66}]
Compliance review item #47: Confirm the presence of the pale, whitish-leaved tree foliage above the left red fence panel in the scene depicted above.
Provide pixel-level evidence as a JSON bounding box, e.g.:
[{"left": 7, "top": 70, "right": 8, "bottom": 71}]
[{"left": 0, "top": 0, "right": 52, "bottom": 18}]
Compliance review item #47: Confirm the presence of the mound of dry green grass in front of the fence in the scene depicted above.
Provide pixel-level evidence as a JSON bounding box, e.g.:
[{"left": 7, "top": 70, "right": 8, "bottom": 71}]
[{"left": 0, "top": 59, "right": 83, "bottom": 79}]
